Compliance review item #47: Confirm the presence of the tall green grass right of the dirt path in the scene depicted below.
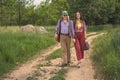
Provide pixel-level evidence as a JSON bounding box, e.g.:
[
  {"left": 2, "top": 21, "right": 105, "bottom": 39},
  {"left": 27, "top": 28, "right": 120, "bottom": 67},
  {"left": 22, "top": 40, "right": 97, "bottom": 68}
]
[{"left": 92, "top": 28, "right": 120, "bottom": 80}]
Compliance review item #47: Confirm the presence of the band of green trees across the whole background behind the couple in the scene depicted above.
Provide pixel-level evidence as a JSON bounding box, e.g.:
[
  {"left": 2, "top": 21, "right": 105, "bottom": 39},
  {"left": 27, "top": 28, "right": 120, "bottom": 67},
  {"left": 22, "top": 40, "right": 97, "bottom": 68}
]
[{"left": 0, "top": 0, "right": 120, "bottom": 26}]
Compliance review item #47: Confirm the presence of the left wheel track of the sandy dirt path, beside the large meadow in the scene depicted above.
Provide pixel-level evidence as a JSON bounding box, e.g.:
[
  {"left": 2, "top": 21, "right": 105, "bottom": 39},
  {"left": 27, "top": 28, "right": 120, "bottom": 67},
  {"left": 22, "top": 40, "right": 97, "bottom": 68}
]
[{"left": 0, "top": 44, "right": 60, "bottom": 80}]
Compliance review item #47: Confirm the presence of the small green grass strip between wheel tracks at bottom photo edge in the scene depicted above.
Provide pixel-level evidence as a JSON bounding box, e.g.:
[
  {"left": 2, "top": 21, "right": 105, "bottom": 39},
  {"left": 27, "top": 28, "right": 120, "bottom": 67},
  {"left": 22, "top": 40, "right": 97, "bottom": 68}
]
[{"left": 50, "top": 68, "right": 67, "bottom": 80}]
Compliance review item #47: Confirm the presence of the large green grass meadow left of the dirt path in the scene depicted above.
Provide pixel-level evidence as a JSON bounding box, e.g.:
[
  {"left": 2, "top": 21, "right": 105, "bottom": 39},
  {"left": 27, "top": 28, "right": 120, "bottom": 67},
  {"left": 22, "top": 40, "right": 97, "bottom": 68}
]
[{"left": 0, "top": 27, "right": 56, "bottom": 75}]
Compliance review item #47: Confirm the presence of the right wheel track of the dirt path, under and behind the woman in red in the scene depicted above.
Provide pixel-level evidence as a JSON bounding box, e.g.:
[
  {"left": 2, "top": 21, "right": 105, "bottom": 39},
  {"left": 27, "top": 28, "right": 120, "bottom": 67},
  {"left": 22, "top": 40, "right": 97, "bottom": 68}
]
[{"left": 65, "top": 34, "right": 102, "bottom": 80}]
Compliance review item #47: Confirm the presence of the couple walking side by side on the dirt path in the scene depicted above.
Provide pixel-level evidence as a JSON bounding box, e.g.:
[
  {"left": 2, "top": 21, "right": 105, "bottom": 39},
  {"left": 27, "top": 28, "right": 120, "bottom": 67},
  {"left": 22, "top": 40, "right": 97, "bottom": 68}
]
[{"left": 55, "top": 11, "right": 86, "bottom": 68}]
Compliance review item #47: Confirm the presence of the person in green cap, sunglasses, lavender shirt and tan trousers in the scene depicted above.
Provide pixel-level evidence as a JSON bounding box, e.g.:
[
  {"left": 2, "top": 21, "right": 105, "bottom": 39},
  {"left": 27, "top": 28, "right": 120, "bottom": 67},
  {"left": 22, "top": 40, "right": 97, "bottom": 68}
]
[{"left": 55, "top": 11, "right": 75, "bottom": 67}]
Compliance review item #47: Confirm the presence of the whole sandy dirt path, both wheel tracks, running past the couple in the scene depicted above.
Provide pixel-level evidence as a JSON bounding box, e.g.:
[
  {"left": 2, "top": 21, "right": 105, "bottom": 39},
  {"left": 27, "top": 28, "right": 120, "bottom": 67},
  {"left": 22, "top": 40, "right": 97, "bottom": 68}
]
[{"left": 0, "top": 32, "right": 101, "bottom": 80}]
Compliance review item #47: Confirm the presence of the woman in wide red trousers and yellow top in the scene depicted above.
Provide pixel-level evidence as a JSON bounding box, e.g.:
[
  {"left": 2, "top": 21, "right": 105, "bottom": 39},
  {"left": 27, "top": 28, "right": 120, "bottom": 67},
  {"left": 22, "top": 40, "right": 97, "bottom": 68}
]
[{"left": 74, "top": 12, "right": 86, "bottom": 68}]
